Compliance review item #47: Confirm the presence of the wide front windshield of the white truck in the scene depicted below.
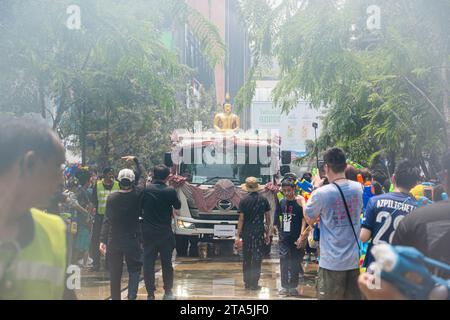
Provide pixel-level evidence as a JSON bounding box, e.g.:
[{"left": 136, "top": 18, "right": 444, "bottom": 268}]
[{"left": 180, "top": 149, "right": 271, "bottom": 185}]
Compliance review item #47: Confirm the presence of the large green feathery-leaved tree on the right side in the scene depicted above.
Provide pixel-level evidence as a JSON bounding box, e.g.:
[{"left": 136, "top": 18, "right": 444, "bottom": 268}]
[{"left": 237, "top": 0, "right": 450, "bottom": 173}]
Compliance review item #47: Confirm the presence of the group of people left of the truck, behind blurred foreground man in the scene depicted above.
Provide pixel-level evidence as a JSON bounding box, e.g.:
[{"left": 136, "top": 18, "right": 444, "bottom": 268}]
[{"left": 56, "top": 156, "right": 181, "bottom": 300}]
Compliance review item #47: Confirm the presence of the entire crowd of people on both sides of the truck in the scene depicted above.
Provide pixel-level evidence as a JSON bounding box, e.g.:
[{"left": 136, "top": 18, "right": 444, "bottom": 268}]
[{"left": 0, "top": 120, "right": 450, "bottom": 300}]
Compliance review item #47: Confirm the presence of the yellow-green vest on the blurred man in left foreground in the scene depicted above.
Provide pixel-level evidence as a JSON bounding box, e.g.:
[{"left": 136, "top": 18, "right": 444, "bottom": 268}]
[{"left": 0, "top": 209, "right": 67, "bottom": 300}]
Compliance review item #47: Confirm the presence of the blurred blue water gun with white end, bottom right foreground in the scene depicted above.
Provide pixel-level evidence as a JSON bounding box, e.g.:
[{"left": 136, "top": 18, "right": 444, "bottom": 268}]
[{"left": 371, "top": 243, "right": 450, "bottom": 300}]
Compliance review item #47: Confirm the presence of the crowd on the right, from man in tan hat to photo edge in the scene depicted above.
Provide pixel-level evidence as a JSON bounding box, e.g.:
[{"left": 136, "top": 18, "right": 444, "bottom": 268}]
[{"left": 236, "top": 148, "right": 450, "bottom": 300}]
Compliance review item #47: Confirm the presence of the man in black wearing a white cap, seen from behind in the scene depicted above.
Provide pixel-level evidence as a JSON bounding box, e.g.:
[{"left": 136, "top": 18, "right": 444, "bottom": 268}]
[{"left": 100, "top": 156, "right": 145, "bottom": 300}]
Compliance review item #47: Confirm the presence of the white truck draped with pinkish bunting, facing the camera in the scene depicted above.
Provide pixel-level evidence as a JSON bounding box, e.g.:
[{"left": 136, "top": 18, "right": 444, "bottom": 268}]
[{"left": 165, "top": 130, "right": 291, "bottom": 256}]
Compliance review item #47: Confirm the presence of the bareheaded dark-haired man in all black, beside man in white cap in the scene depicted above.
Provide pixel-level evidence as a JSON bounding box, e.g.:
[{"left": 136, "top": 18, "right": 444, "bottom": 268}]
[{"left": 142, "top": 165, "right": 181, "bottom": 300}]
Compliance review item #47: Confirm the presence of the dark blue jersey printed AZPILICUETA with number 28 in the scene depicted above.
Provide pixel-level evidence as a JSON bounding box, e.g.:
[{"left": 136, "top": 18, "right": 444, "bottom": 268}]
[{"left": 361, "top": 192, "right": 417, "bottom": 268}]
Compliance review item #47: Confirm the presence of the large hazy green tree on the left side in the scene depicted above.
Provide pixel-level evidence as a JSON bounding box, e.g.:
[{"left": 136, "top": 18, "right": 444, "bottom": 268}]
[{"left": 0, "top": 0, "right": 224, "bottom": 166}]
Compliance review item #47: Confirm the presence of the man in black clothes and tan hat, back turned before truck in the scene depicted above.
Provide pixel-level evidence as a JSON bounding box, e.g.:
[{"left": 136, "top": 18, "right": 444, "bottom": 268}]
[{"left": 236, "top": 177, "right": 271, "bottom": 290}]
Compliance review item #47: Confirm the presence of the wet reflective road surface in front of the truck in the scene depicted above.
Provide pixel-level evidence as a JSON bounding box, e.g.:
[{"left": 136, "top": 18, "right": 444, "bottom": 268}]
[{"left": 77, "top": 241, "right": 318, "bottom": 300}]
